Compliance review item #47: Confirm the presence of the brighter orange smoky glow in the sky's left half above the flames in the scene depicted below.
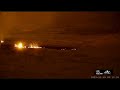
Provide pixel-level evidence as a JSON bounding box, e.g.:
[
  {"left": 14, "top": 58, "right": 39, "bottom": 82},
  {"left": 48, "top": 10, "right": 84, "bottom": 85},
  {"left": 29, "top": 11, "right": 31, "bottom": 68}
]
[{"left": 0, "top": 12, "right": 55, "bottom": 37}]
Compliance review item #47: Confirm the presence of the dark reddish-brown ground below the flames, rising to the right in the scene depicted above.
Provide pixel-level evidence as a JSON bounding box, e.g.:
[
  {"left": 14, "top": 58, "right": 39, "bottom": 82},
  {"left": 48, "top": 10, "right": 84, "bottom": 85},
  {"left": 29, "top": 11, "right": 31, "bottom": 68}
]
[{"left": 0, "top": 34, "right": 120, "bottom": 78}]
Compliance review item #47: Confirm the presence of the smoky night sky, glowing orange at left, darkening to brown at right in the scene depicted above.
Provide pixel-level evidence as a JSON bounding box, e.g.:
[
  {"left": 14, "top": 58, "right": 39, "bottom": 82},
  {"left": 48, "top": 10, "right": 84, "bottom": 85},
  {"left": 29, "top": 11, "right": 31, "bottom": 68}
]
[{"left": 0, "top": 12, "right": 120, "bottom": 38}]
